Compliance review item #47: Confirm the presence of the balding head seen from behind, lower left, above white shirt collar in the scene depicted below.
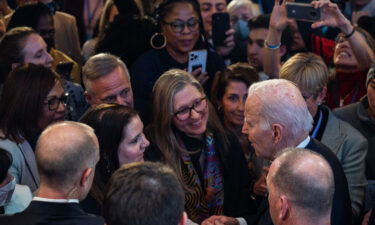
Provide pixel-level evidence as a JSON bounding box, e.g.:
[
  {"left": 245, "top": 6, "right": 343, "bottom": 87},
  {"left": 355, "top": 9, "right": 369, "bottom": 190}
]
[{"left": 35, "top": 122, "right": 99, "bottom": 200}]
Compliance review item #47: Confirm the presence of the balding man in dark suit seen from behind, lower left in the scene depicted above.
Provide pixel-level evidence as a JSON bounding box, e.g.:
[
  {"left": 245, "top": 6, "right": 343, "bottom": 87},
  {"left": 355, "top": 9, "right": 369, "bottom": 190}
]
[{"left": 0, "top": 122, "right": 104, "bottom": 225}]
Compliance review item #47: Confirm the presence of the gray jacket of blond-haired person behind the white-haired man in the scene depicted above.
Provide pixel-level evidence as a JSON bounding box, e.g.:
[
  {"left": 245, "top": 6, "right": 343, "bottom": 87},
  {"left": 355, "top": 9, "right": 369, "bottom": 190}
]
[{"left": 321, "top": 107, "right": 368, "bottom": 217}]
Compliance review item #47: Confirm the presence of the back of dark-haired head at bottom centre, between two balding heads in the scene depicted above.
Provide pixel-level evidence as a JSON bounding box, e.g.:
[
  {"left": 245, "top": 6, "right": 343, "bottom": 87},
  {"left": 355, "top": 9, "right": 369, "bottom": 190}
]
[{"left": 104, "top": 162, "right": 186, "bottom": 225}]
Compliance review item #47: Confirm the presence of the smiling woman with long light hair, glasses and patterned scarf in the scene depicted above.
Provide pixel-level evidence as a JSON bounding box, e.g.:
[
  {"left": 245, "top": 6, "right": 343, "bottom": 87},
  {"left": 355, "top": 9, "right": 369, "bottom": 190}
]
[{"left": 145, "top": 69, "right": 254, "bottom": 224}]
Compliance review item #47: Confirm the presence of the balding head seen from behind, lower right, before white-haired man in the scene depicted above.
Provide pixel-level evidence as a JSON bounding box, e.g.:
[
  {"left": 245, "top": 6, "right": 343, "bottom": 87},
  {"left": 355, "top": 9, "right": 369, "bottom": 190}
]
[{"left": 267, "top": 148, "right": 335, "bottom": 225}]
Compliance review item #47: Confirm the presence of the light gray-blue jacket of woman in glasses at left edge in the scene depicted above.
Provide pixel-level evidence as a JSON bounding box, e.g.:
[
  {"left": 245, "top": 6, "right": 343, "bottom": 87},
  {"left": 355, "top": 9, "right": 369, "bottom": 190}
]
[{"left": 0, "top": 136, "right": 39, "bottom": 192}]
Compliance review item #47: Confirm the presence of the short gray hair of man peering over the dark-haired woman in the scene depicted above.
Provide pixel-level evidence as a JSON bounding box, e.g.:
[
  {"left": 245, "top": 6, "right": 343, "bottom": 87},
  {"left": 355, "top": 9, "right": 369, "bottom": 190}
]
[{"left": 82, "top": 53, "right": 130, "bottom": 91}]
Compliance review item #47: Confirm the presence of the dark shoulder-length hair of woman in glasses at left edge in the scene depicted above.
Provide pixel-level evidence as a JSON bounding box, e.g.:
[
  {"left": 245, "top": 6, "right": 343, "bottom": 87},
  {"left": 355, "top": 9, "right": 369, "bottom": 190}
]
[{"left": 0, "top": 64, "right": 61, "bottom": 143}]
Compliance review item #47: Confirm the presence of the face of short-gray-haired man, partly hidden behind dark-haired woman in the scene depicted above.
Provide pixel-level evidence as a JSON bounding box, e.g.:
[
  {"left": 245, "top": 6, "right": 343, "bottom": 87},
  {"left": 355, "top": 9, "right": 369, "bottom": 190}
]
[{"left": 86, "top": 66, "right": 133, "bottom": 107}]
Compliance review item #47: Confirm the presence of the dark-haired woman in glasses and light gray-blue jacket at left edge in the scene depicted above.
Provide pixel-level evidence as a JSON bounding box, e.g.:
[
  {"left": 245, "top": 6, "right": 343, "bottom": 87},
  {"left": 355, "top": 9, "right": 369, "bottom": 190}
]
[{"left": 0, "top": 64, "right": 67, "bottom": 192}]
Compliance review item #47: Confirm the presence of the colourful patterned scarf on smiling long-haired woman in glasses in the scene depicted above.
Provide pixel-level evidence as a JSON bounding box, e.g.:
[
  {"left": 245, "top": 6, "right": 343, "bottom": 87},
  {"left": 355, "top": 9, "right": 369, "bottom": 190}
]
[{"left": 182, "top": 136, "right": 224, "bottom": 224}]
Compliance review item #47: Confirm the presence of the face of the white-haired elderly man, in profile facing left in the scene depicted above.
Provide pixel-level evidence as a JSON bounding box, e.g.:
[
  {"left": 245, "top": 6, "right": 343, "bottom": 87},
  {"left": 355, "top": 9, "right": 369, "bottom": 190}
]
[{"left": 242, "top": 95, "right": 275, "bottom": 160}]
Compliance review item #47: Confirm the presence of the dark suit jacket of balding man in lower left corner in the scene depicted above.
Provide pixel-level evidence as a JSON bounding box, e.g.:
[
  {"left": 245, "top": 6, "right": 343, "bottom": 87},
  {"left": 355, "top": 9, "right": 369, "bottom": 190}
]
[{"left": 0, "top": 201, "right": 104, "bottom": 225}]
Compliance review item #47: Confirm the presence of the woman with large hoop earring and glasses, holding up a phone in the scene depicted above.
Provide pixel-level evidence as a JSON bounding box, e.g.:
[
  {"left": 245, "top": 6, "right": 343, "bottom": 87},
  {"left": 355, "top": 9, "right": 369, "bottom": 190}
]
[{"left": 131, "top": 0, "right": 225, "bottom": 124}]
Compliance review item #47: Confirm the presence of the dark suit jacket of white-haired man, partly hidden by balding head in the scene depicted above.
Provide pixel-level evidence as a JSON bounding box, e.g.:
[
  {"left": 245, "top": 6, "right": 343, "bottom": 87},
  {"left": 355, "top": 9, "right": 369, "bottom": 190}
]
[{"left": 245, "top": 138, "right": 352, "bottom": 225}]
